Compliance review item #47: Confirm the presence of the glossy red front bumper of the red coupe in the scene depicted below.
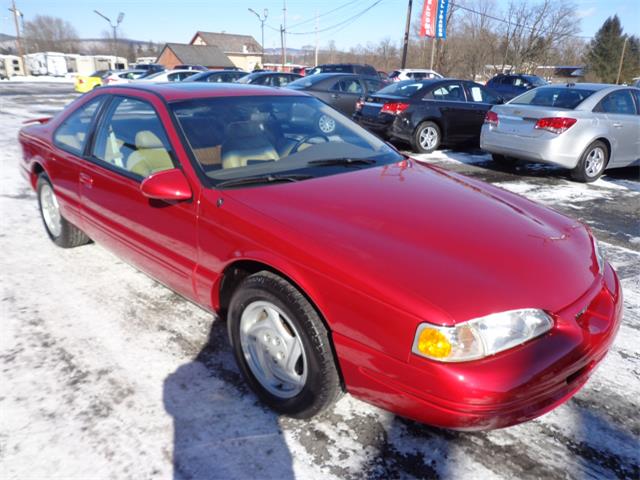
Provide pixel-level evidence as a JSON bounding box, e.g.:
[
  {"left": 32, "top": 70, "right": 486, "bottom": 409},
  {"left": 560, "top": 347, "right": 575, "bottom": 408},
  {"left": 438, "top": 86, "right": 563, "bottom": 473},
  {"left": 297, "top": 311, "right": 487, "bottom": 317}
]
[{"left": 334, "top": 265, "right": 622, "bottom": 430}]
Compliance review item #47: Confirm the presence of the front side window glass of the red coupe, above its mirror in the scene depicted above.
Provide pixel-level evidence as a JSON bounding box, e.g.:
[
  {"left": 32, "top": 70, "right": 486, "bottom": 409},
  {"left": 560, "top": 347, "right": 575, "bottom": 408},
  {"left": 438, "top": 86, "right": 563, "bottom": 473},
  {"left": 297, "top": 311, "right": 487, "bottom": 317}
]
[{"left": 93, "top": 97, "right": 173, "bottom": 177}]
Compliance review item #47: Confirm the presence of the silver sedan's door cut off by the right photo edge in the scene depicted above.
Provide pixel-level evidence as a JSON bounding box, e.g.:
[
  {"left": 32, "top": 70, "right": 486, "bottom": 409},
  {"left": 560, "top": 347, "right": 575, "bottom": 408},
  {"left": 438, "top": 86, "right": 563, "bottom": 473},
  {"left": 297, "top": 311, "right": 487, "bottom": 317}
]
[{"left": 593, "top": 88, "right": 640, "bottom": 166}]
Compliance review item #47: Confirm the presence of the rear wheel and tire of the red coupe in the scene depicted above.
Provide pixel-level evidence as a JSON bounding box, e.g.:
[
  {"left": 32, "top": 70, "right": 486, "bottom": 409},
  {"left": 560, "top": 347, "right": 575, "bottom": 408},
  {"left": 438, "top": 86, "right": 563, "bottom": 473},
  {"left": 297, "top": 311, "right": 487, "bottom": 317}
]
[{"left": 36, "top": 173, "right": 91, "bottom": 248}]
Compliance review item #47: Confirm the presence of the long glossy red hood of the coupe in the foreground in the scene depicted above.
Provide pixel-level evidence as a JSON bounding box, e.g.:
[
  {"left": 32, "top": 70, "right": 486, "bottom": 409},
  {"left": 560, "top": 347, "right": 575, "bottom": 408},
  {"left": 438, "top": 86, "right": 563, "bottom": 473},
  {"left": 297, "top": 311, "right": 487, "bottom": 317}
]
[{"left": 228, "top": 160, "right": 597, "bottom": 324}]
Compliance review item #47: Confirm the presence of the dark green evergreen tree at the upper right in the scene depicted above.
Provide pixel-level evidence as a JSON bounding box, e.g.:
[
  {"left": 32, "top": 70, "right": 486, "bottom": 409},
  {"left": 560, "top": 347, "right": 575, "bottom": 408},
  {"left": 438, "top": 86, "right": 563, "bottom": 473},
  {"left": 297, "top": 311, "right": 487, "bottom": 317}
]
[{"left": 585, "top": 15, "right": 640, "bottom": 83}]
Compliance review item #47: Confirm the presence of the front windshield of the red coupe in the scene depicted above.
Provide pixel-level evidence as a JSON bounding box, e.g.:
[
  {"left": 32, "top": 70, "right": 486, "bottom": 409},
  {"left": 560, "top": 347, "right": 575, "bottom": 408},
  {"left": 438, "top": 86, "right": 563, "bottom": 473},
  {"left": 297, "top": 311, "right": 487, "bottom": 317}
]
[{"left": 172, "top": 96, "right": 403, "bottom": 186}]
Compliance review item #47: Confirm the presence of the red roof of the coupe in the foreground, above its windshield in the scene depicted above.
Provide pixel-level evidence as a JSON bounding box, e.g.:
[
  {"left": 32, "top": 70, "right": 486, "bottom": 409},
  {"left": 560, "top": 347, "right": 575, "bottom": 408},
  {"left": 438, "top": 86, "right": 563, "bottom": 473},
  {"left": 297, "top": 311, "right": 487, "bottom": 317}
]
[{"left": 101, "top": 82, "right": 307, "bottom": 102}]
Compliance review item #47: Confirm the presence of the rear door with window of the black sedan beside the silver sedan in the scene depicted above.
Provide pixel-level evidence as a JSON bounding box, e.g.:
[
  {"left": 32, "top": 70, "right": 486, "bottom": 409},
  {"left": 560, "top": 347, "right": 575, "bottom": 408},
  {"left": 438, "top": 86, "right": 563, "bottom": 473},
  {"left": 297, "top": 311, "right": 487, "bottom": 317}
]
[{"left": 425, "top": 81, "right": 475, "bottom": 143}]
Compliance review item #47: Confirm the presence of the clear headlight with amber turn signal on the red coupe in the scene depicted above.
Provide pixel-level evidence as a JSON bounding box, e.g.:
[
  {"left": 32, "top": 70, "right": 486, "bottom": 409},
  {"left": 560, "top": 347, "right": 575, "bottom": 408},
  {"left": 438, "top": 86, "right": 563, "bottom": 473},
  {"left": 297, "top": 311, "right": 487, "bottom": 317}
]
[{"left": 412, "top": 308, "right": 553, "bottom": 362}]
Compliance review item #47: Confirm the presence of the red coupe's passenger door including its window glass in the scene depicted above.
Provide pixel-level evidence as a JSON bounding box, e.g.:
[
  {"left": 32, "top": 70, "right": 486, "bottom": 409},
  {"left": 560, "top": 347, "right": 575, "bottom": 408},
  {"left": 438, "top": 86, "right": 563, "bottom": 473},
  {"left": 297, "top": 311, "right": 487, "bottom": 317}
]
[{"left": 79, "top": 92, "right": 198, "bottom": 299}]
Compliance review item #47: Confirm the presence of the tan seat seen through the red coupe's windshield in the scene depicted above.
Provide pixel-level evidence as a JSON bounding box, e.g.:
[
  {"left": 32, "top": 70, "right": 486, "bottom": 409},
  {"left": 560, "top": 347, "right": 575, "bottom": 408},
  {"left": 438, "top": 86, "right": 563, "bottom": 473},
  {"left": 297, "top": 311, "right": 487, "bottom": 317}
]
[{"left": 222, "top": 122, "right": 280, "bottom": 168}]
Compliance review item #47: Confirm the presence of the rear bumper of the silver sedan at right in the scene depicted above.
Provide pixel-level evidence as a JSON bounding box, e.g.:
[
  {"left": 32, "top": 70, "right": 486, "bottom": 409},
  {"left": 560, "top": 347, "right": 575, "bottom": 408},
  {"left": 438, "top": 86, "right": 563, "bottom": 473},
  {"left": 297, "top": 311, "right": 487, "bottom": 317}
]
[{"left": 480, "top": 124, "right": 583, "bottom": 168}]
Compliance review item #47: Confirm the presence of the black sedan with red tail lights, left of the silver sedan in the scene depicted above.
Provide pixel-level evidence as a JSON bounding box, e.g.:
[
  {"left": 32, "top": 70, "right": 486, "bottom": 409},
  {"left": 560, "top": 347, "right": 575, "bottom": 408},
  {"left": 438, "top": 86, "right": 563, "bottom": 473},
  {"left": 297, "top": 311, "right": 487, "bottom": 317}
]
[{"left": 354, "top": 79, "right": 502, "bottom": 153}]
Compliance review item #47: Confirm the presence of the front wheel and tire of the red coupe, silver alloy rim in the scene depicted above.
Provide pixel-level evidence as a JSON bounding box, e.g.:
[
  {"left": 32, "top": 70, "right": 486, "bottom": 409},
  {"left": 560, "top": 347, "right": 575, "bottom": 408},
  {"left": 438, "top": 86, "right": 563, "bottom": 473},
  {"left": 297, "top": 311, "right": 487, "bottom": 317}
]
[{"left": 227, "top": 271, "right": 342, "bottom": 418}]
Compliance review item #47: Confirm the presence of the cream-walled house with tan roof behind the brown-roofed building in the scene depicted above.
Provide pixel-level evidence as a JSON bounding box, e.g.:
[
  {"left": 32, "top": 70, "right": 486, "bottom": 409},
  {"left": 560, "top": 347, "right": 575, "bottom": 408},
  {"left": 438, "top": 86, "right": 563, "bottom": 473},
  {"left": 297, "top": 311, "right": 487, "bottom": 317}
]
[{"left": 189, "top": 32, "right": 264, "bottom": 72}]
